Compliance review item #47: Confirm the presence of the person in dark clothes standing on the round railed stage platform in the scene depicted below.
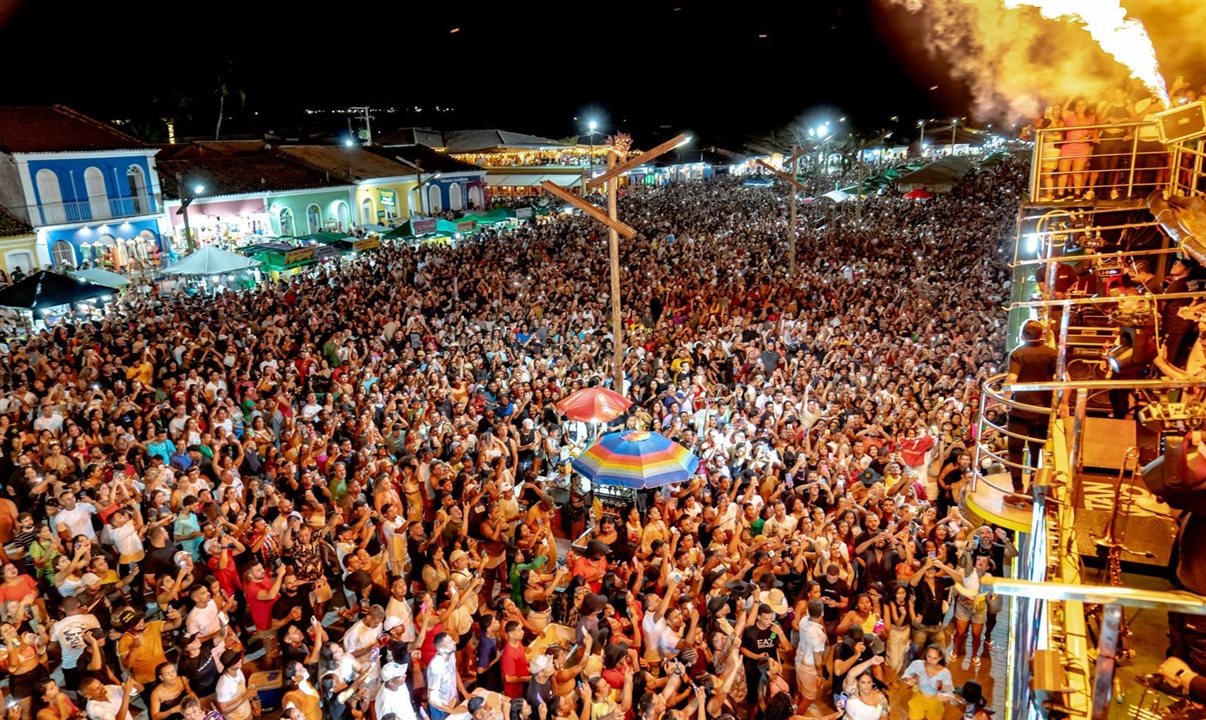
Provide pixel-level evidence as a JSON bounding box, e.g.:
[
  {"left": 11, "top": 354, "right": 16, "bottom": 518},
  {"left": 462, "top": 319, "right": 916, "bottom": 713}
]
[{"left": 1005, "top": 320, "right": 1056, "bottom": 493}]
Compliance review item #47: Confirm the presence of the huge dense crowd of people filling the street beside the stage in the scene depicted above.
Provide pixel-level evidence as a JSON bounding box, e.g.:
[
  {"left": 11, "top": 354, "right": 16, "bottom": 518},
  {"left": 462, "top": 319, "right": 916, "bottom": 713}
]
[{"left": 0, "top": 158, "right": 1025, "bottom": 720}]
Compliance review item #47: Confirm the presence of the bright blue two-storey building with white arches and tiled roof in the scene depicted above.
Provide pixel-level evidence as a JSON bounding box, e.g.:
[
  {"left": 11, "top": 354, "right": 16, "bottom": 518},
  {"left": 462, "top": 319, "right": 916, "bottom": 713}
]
[{"left": 0, "top": 105, "right": 166, "bottom": 270}]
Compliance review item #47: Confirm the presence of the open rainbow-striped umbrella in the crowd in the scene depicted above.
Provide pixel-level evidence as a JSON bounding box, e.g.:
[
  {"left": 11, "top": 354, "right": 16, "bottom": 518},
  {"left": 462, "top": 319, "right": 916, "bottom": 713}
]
[{"left": 574, "top": 431, "right": 699, "bottom": 490}]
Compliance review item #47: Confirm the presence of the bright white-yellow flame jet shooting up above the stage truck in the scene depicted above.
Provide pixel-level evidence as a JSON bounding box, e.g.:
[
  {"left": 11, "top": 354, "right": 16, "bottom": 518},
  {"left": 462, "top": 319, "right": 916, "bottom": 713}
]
[{"left": 1005, "top": 0, "right": 1170, "bottom": 107}]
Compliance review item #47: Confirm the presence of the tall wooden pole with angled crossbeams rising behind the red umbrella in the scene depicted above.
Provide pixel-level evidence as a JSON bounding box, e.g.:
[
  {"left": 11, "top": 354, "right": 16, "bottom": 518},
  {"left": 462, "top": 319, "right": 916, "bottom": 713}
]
[{"left": 540, "top": 135, "right": 691, "bottom": 393}]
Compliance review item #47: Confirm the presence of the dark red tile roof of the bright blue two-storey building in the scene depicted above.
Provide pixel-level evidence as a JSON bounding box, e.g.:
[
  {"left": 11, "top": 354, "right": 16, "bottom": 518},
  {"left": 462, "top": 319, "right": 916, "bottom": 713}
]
[{"left": 0, "top": 105, "right": 147, "bottom": 152}]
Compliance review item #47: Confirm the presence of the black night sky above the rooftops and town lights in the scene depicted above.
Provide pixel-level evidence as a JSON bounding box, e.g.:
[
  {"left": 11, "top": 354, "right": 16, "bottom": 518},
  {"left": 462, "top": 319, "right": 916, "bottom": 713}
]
[{"left": 0, "top": 0, "right": 967, "bottom": 147}]
